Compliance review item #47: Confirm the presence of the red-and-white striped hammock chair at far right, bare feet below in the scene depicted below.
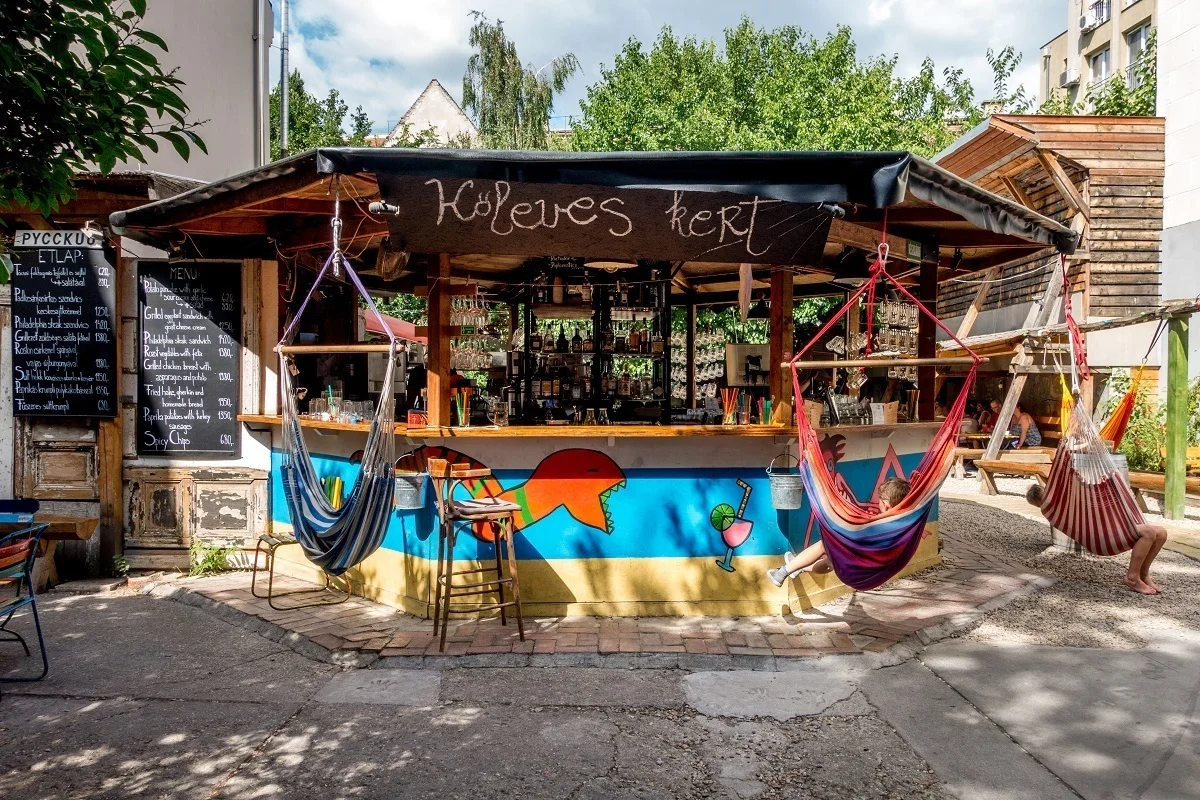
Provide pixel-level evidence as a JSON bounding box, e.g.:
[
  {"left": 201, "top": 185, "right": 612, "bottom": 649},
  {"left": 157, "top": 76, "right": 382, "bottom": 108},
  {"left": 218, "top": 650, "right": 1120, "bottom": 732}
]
[{"left": 1042, "top": 253, "right": 1142, "bottom": 555}]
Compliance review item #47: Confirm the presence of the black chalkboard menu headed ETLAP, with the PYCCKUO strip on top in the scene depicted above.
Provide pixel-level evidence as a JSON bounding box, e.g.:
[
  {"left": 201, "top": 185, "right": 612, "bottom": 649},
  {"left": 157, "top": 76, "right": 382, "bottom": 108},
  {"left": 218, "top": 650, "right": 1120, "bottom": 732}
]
[{"left": 12, "top": 230, "right": 116, "bottom": 417}]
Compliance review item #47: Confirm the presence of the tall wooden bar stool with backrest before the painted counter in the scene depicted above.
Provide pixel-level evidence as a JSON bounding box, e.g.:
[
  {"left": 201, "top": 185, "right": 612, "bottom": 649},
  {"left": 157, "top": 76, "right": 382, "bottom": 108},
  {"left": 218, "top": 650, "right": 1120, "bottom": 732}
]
[{"left": 428, "top": 458, "right": 524, "bottom": 651}]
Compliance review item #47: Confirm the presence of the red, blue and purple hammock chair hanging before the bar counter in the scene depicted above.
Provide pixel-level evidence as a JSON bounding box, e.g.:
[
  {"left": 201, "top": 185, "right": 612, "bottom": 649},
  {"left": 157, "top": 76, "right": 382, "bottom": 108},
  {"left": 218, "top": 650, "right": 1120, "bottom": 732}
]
[{"left": 791, "top": 245, "right": 980, "bottom": 591}]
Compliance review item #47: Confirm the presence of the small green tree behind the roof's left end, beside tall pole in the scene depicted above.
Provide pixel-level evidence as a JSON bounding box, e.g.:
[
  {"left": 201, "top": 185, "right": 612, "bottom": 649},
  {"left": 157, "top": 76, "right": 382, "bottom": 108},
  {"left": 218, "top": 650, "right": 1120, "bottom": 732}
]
[{"left": 270, "top": 71, "right": 371, "bottom": 161}]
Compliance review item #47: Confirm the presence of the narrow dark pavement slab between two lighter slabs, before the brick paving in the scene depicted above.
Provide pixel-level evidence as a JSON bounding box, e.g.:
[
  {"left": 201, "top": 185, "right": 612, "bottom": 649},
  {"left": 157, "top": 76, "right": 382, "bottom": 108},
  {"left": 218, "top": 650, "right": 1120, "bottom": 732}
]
[{"left": 442, "top": 667, "right": 684, "bottom": 709}]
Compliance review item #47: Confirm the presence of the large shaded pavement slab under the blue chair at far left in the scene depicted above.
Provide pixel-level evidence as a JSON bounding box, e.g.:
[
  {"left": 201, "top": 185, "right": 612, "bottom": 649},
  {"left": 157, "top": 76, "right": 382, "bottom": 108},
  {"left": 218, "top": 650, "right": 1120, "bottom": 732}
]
[{"left": 0, "top": 595, "right": 336, "bottom": 703}]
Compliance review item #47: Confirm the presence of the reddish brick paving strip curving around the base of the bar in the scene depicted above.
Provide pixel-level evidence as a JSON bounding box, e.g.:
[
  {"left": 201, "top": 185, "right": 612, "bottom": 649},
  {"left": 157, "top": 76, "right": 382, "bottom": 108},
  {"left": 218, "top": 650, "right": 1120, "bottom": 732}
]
[{"left": 159, "top": 536, "right": 1045, "bottom": 660}]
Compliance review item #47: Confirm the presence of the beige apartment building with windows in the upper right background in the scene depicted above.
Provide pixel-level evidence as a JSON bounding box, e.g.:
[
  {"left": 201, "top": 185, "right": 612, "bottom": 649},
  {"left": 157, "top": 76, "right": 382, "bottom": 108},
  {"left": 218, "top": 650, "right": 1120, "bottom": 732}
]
[{"left": 1038, "top": 0, "right": 1158, "bottom": 103}]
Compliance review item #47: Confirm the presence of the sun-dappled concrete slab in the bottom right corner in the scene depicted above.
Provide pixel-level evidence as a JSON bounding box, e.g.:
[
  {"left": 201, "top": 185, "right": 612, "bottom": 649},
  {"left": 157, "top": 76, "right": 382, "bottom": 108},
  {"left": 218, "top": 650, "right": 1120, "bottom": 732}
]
[{"left": 922, "top": 633, "right": 1200, "bottom": 800}]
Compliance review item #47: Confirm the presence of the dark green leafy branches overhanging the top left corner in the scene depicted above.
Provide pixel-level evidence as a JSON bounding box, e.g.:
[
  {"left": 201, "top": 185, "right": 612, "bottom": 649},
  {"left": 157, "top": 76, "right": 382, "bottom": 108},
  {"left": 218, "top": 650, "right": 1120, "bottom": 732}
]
[{"left": 0, "top": 0, "right": 204, "bottom": 212}]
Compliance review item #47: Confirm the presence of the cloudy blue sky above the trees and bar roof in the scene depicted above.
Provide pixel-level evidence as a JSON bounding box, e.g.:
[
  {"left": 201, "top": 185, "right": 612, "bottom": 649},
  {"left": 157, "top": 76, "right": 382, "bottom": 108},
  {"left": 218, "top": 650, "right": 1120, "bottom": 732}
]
[{"left": 271, "top": 0, "right": 1068, "bottom": 131}]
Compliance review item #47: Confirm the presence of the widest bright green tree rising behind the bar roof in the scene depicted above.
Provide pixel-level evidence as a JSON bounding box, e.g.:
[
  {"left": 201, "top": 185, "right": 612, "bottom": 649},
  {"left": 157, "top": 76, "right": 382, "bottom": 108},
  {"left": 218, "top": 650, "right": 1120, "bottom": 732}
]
[{"left": 574, "top": 18, "right": 982, "bottom": 155}]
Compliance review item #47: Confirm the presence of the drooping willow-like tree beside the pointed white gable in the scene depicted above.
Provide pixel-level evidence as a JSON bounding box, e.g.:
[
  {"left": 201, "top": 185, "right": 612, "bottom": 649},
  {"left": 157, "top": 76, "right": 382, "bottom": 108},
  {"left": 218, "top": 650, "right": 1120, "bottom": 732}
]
[{"left": 462, "top": 11, "right": 580, "bottom": 150}]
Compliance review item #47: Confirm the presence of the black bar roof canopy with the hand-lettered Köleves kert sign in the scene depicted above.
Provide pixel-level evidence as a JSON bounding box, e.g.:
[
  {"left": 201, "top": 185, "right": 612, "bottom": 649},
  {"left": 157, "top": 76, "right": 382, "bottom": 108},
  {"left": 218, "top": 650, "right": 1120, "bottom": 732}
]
[{"left": 110, "top": 148, "right": 1078, "bottom": 264}]
